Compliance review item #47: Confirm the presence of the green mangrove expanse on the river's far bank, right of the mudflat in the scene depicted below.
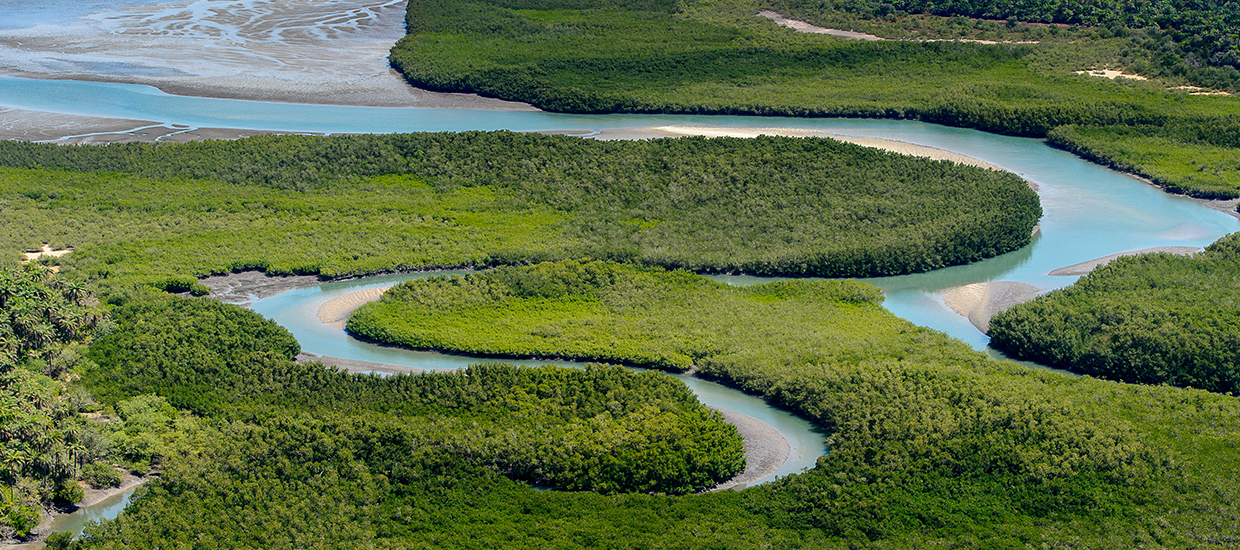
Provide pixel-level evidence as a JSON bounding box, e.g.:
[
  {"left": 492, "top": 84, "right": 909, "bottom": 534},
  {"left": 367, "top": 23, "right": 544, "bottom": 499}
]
[{"left": 392, "top": 0, "right": 1240, "bottom": 198}]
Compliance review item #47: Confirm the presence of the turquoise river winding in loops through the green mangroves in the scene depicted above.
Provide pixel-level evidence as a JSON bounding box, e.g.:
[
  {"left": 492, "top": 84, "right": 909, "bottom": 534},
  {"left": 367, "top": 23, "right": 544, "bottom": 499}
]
[{"left": 0, "top": 77, "right": 1240, "bottom": 537}]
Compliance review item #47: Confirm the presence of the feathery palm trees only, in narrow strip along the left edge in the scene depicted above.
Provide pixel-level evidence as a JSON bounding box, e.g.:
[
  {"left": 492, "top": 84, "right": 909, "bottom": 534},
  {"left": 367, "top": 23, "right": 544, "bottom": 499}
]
[{"left": 0, "top": 265, "right": 99, "bottom": 540}]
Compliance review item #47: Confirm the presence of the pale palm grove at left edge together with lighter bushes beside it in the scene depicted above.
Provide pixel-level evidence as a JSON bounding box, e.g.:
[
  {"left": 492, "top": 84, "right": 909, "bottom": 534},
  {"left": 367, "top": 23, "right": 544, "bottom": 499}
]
[{"left": 0, "top": 265, "right": 190, "bottom": 540}]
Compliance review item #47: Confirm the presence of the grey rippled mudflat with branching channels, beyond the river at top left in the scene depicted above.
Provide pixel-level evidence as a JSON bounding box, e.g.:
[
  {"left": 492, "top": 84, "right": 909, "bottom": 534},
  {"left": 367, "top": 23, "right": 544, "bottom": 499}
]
[{"left": 0, "top": 0, "right": 528, "bottom": 109}]
